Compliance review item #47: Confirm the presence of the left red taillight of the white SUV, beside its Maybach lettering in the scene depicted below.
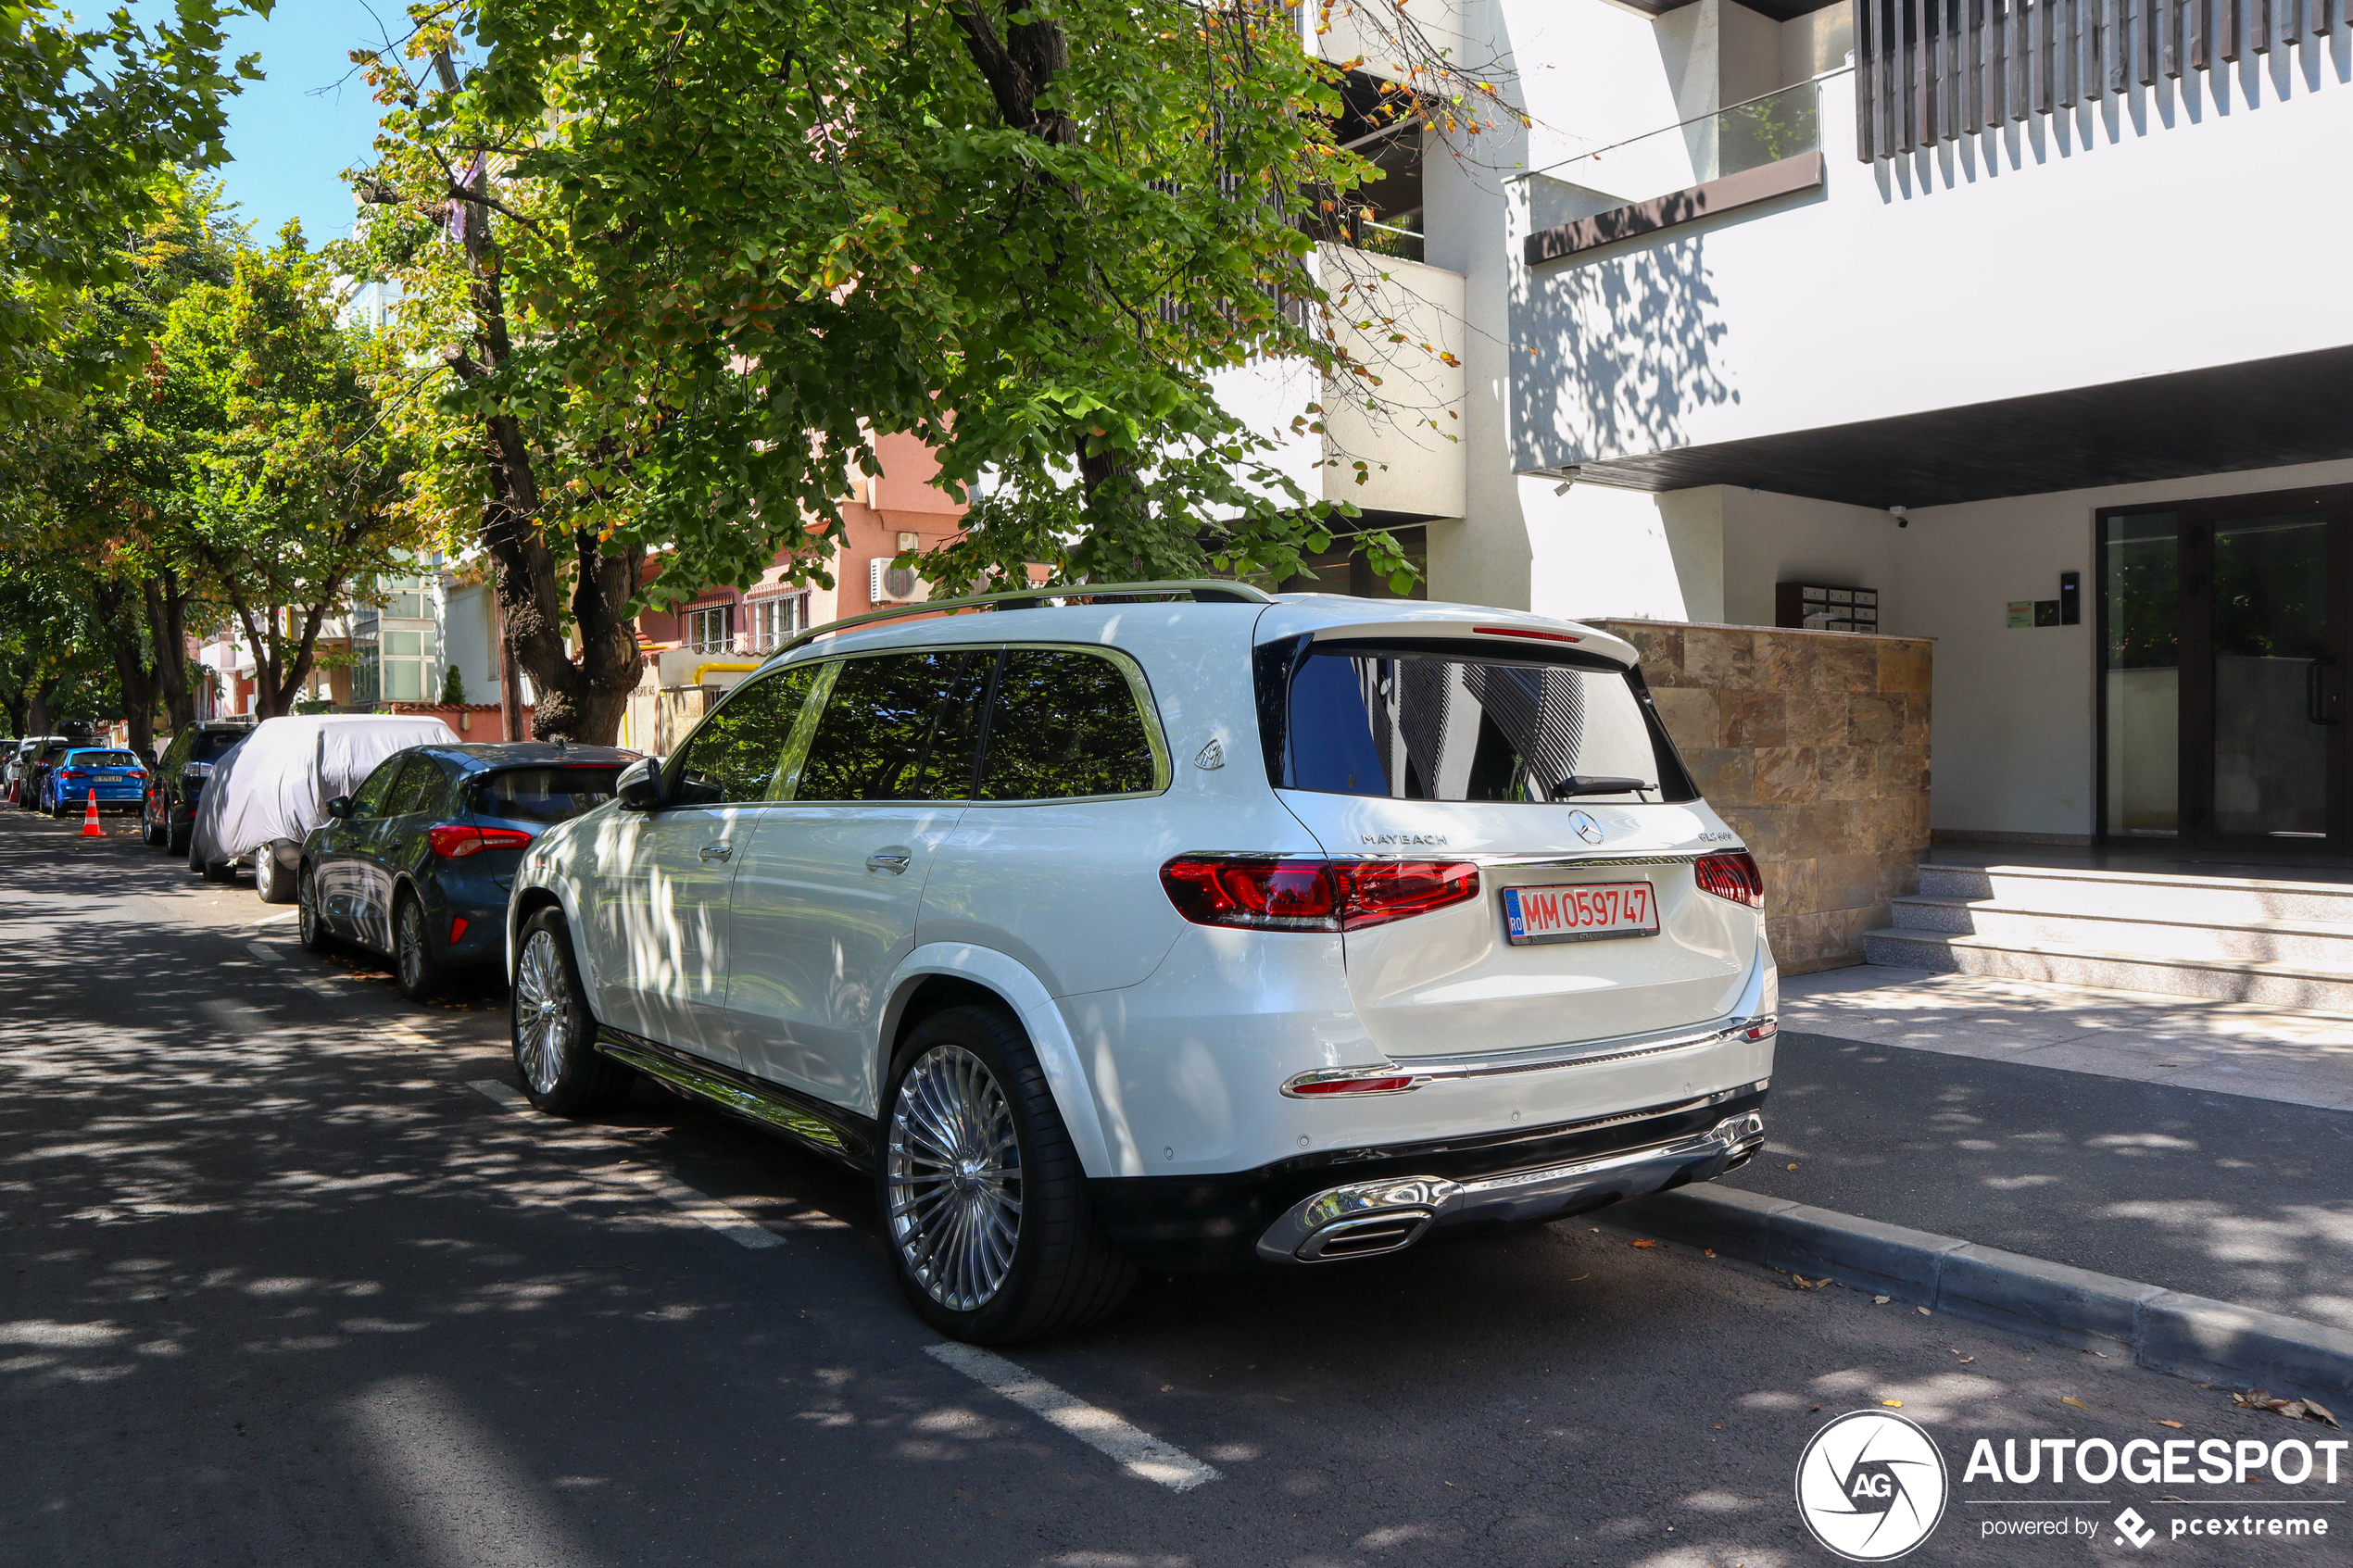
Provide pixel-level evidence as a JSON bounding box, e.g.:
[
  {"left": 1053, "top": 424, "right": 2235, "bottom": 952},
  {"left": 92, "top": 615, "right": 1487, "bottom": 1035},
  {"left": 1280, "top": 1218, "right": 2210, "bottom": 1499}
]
[{"left": 1160, "top": 856, "right": 1478, "bottom": 931}]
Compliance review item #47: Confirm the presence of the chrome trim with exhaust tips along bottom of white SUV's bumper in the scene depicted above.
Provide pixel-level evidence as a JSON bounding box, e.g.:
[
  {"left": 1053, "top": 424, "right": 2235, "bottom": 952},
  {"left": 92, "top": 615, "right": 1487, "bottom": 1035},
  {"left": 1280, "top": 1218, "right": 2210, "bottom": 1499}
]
[{"left": 1256, "top": 1112, "right": 1765, "bottom": 1262}]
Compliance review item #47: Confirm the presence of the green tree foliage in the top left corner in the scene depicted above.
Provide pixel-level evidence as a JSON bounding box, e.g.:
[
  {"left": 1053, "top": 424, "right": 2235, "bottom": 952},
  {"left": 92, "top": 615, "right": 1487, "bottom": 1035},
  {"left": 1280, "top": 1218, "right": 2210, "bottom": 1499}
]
[{"left": 0, "top": 0, "right": 271, "bottom": 425}]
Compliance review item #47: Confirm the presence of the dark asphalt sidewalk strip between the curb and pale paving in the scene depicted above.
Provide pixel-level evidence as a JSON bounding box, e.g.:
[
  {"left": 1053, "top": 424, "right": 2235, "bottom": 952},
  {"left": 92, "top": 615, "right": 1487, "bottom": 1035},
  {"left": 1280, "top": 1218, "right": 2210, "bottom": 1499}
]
[{"left": 1730, "top": 1032, "right": 2353, "bottom": 1328}]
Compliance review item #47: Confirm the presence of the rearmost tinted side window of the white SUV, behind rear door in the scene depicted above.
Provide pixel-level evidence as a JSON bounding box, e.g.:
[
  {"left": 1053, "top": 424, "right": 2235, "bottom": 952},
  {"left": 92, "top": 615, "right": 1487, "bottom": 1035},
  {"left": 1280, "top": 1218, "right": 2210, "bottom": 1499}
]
[{"left": 979, "top": 649, "right": 1160, "bottom": 799}]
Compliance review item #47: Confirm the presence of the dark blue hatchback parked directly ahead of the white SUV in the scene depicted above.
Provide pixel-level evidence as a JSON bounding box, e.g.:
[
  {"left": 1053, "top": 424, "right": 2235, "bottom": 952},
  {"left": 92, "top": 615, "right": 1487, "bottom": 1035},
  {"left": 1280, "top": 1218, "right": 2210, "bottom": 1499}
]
[{"left": 296, "top": 741, "right": 637, "bottom": 999}]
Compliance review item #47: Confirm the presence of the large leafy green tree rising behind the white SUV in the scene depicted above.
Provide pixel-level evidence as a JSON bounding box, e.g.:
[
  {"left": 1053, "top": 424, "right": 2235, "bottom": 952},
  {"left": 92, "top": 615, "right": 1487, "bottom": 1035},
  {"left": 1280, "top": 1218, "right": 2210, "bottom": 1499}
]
[{"left": 336, "top": 0, "right": 1505, "bottom": 741}]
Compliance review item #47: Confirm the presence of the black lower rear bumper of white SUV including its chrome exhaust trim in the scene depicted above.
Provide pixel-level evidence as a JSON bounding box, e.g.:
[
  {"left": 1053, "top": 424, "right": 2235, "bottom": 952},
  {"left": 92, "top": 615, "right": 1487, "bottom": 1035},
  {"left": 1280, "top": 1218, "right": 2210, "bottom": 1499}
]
[{"left": 1089, "top": 1079, "right": 1769, "bottom": 1270}]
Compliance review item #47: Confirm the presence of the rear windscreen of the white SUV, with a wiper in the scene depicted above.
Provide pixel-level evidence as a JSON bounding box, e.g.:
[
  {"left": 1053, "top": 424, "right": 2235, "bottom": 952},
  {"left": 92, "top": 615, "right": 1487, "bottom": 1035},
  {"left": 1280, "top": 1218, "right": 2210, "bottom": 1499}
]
[{"left": 1280, "top": 644, "right": 1696, "bottom": 804}]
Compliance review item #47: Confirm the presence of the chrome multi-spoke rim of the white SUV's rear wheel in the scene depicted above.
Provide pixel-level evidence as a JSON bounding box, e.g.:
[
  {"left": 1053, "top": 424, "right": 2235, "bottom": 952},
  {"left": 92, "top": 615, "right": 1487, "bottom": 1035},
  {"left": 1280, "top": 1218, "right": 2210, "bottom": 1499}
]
[{"left": 883, "top": 1044, "right": 1021, "bottom": 1311}]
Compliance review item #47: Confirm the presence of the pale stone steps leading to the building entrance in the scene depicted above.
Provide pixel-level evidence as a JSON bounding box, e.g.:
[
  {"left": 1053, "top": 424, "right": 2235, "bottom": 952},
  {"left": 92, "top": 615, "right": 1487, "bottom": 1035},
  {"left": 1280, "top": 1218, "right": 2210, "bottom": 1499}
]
[{"left": 1864, "top": 865, "right": 2353, "bottom": 1013}]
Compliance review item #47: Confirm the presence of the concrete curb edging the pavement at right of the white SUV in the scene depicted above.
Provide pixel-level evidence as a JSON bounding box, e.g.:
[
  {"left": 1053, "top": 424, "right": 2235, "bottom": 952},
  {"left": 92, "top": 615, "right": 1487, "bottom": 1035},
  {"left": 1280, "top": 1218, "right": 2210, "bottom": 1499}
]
[{"left": 1607, "top": 1185, "right": 2353, "bottom": 1399}]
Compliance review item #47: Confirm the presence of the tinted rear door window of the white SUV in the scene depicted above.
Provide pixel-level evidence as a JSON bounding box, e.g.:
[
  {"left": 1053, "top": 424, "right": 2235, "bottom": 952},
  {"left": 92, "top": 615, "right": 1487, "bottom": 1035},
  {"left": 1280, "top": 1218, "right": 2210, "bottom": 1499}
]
[{"left": 793, "top": 651, "right": 988, "bottom": 799}]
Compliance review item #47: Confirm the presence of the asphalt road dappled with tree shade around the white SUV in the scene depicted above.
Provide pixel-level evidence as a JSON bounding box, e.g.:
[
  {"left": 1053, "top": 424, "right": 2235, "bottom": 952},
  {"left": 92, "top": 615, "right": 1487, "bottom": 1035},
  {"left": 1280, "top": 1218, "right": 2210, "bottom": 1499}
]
[{"left": 0, "top": 813, "right": 2353, "bottom": 1568}]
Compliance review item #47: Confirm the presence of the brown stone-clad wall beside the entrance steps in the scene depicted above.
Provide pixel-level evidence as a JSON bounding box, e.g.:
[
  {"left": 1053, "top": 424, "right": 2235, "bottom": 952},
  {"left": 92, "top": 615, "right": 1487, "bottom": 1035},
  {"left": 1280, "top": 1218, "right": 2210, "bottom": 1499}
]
[{"left": 1593, "top": 621, "right": 1931, "bottom": 973}]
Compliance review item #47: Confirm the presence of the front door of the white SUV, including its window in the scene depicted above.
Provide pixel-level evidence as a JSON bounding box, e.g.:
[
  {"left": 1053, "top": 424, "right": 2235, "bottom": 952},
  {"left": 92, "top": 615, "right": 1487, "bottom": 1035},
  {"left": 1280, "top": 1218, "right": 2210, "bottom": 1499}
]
[{"left": 593, "top": 668, "right": 810, "bottom": 1062}]
